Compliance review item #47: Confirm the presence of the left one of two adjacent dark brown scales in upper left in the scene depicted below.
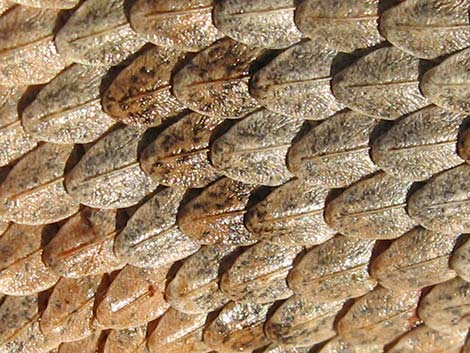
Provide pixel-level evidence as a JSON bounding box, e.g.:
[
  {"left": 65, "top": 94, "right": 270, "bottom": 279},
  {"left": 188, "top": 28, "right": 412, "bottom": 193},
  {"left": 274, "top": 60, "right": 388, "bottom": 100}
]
[{"left": 103, "top": 47, "right": 185, "bottom": 126}]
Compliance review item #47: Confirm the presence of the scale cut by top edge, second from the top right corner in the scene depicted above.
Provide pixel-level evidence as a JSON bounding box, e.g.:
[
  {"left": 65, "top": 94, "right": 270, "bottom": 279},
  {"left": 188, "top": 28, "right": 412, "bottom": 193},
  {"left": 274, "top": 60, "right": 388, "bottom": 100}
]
[{"left": 295, "top": 0, "right": 384, "bottom": 52}]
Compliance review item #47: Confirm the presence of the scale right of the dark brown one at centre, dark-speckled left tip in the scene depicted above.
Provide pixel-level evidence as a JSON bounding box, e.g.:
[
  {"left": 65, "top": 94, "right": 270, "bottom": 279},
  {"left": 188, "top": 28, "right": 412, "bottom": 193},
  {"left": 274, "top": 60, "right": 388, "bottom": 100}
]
[{"left": 245, "top": 179, "right": 335, "bottom": 246}]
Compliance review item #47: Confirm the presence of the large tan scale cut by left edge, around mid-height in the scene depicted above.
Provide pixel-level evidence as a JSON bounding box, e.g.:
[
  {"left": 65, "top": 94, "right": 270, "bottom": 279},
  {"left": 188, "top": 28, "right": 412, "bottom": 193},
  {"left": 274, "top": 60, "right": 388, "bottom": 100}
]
[{"left": 0, "top": 143, "right": 78, "bottom": 225}]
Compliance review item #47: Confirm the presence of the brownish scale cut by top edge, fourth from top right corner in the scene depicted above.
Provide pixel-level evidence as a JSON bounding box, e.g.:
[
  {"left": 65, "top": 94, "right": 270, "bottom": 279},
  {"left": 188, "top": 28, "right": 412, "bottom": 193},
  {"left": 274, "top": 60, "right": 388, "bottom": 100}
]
[{"left": 130, "top": 0, "right": 223, "bottom": 51}]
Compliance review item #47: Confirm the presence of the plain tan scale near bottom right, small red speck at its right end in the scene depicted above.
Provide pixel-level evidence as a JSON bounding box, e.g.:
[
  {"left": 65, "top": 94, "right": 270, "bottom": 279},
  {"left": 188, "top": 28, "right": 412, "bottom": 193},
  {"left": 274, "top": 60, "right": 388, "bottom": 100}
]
[{"left": 337, "top": 287, "right": 420, "bottom": 345}]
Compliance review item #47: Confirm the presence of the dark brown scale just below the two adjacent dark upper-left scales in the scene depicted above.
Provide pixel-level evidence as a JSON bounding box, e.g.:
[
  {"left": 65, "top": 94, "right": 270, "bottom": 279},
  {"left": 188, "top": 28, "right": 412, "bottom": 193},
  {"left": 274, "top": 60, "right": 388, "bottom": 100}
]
[{"left": 139, "top": 113, "right": 223, "bottom": 188}]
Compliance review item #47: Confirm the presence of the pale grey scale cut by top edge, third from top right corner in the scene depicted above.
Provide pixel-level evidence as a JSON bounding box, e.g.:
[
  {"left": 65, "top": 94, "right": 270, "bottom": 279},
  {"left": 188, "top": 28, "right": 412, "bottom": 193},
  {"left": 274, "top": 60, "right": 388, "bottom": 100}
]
[{"left": 213, "top": 0, "right": 302, "bottom": 49}]
